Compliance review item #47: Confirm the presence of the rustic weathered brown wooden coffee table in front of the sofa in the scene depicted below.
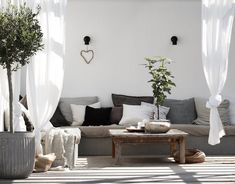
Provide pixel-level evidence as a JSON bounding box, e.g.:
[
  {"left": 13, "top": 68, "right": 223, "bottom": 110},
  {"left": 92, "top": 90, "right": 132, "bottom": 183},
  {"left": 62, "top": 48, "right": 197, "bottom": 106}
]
[{"left": 109, "top": 129, "right": 188, "bottom": 164}]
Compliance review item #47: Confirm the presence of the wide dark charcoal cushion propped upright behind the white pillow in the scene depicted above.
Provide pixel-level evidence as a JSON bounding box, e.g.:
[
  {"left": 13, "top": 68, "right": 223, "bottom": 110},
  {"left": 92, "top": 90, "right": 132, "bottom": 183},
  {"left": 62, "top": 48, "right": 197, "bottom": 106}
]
[{"left": 112, "top": 94, "right": 154, "bottom": 106}]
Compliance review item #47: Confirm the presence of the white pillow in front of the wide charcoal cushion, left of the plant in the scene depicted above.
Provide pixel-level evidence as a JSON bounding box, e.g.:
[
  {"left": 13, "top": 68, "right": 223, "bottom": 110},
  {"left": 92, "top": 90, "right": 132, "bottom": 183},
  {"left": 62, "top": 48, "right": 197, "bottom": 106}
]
[{"left": 119, "top": 104, "right": 153, "bottom": 126}]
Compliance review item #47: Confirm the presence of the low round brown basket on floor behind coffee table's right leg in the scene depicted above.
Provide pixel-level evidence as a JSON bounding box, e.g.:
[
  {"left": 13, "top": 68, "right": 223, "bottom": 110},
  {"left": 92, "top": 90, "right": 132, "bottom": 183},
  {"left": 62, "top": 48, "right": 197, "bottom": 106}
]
[{"left": 173, "top": 149, "right": 206, "bottom": 163}]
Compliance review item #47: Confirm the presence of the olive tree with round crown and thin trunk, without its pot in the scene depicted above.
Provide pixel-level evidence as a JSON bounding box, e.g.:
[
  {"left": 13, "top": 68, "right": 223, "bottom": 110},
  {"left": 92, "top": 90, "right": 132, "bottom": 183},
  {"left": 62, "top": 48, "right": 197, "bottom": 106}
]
[{"left": 0, "top": 3, "right": 43, "bottom": 133}]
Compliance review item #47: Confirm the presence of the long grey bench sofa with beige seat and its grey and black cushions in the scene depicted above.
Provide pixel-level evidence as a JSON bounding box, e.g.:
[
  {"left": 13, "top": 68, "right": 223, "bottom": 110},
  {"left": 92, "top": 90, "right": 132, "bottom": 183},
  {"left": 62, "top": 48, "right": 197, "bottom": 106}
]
[{"left": 46, "top": 94, "right": 235, "bottom": 156}]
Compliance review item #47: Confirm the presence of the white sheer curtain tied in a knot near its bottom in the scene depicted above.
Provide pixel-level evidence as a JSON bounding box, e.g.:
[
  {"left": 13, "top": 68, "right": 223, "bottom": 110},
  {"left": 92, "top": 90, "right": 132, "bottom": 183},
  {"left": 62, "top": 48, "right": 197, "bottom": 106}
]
[{"left": 202, "top": 0, "right": 234, "bottom": 145}]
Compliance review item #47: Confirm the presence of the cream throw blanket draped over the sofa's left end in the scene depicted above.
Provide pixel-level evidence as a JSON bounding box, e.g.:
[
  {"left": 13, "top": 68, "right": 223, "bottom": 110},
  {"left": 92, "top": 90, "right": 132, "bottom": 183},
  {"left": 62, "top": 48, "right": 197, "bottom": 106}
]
[{"left": 45, "top": 128, "right": 81, "bottom": 168}]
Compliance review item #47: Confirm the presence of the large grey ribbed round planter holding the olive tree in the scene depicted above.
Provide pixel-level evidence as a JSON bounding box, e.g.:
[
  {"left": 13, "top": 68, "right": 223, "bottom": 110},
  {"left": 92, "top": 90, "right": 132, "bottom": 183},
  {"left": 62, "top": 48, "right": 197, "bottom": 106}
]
[{"left": 0, "top": 132, "right": 35, "bottom": 179}]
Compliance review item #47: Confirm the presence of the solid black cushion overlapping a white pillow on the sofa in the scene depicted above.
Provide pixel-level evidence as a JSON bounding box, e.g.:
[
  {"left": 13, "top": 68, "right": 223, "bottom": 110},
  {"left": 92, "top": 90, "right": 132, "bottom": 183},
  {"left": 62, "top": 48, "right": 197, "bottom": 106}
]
[{"left": 83, "top": 106, "right": 112, "bottom": 126}]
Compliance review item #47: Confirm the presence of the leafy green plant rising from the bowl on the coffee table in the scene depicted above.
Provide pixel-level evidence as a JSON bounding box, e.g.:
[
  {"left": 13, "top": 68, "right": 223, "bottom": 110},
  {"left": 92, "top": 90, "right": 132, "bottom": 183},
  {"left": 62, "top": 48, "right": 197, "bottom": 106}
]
[{"left": 144, "top": 56, "right": 176, "bottom": 132}]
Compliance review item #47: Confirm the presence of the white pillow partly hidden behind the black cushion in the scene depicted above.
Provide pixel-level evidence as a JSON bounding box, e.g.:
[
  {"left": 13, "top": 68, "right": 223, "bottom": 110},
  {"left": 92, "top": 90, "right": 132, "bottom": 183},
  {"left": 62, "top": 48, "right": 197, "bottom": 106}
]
[{"left": 70, "top": 102, "right": 101, "bottom": 126}]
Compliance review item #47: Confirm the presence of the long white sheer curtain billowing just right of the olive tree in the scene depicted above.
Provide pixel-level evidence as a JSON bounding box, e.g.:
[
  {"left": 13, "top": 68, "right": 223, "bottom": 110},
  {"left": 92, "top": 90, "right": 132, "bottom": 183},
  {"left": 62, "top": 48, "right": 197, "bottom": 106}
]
[{"left": 26, "top": 0, "right": 67, "bottom": 154}]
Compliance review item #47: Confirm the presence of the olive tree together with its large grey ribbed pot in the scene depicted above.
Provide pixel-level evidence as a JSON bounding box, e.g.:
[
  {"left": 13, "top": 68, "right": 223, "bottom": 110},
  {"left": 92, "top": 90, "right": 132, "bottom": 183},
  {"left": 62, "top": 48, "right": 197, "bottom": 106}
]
[{"left": 0, "top": 2, "right": 43, "bottom": 178}]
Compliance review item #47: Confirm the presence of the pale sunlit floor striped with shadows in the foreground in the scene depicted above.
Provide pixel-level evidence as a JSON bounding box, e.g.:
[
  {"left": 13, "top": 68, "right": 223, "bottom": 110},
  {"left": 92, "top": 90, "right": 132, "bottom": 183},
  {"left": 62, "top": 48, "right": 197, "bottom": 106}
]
[{"left": 0, "top": 156, "right": 235, "bottom": 184}]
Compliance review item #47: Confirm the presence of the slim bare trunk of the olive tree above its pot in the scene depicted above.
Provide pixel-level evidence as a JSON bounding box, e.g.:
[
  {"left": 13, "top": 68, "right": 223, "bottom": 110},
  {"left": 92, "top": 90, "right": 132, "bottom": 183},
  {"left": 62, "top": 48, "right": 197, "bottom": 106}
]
[{"left": 7, "top": 65, "right": 14, "bottom": 133}]
